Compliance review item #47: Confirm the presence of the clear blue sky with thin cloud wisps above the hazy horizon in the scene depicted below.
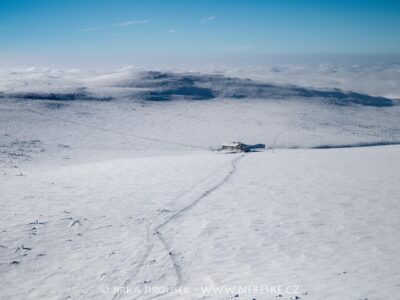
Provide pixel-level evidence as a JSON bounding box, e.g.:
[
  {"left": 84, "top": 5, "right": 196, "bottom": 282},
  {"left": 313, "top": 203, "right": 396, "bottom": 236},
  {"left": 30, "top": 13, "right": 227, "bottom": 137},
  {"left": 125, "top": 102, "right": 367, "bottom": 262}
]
[{"left": 0, "top": 0, "right": 400, "bottom": 55}]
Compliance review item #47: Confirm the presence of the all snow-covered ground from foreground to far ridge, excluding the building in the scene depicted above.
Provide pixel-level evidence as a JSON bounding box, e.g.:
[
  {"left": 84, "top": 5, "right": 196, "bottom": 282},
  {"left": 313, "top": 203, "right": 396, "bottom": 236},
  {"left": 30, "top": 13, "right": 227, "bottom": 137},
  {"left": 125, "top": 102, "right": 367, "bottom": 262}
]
[{"left": 0, "top": 68, "right": 400, "bottom": 300}]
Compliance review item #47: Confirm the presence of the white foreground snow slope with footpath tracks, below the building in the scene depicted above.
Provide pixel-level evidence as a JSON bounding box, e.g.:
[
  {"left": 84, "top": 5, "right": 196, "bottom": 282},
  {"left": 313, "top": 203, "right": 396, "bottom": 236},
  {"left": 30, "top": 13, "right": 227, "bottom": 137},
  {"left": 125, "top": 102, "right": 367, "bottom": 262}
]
[{"left": 0, "top": 146, "right": 400, "bottom": 299}]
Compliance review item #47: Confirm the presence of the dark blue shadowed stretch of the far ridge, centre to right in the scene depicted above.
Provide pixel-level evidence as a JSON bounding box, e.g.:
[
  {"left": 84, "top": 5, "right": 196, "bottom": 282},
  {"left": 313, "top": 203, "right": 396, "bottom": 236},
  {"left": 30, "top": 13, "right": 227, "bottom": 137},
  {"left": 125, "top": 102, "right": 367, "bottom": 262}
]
[{"left": 134, "top": 72, "right": 393, "bottom": 107}]
